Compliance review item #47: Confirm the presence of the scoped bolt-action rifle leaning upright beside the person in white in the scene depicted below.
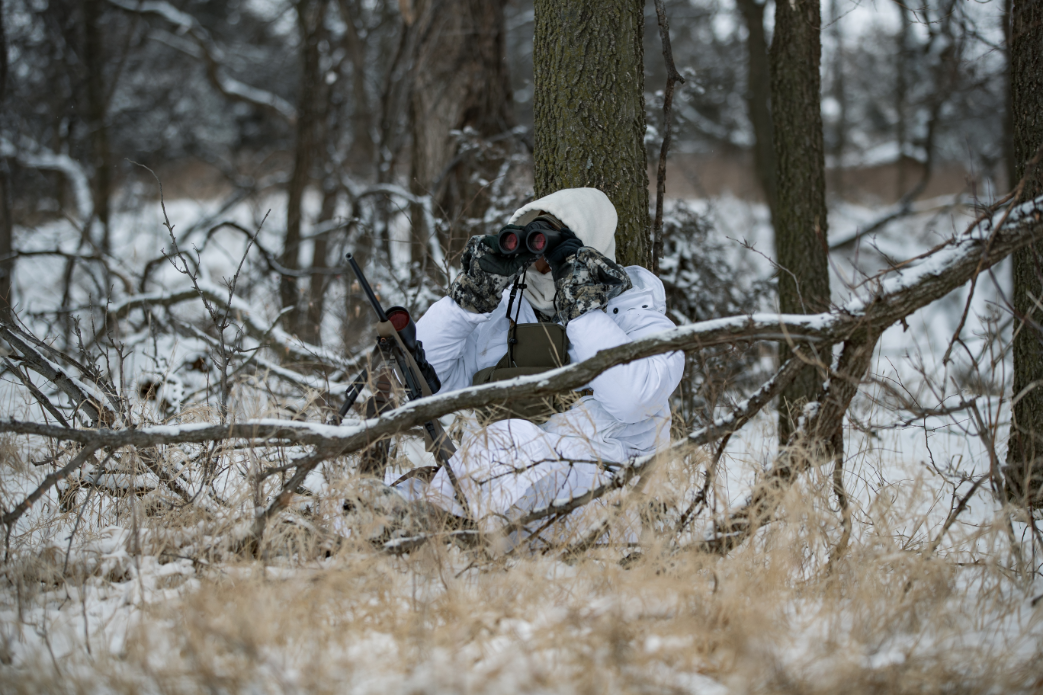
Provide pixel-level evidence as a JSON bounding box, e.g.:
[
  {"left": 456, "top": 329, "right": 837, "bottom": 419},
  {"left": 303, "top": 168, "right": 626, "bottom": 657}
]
[{"left": 340, "top": 254, "right": 470, "bottom": 517}]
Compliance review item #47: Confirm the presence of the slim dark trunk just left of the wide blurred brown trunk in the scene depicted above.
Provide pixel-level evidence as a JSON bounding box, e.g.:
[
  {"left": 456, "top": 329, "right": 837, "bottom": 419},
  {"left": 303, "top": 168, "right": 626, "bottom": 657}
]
[{"left": 278, "top": 0, "right": 326, "bottom": 333}]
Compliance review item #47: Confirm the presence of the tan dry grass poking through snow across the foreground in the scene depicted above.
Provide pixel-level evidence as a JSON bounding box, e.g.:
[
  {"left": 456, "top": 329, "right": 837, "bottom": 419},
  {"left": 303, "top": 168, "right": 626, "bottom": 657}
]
[{"left": 0, "top": 429, "right": 1043, "bottom": 693}]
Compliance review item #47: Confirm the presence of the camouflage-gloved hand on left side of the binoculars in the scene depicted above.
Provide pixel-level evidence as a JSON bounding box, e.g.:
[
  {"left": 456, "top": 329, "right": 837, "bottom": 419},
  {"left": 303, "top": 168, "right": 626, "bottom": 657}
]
[{"left": 450, "top": 236, "right": 535, "bottom": 314}]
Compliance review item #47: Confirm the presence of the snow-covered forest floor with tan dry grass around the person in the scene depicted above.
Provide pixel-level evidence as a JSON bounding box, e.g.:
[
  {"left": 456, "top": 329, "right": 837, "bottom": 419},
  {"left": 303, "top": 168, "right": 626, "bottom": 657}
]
[{"left": 0, "top": 186, "right": 1043, "bottom": 693}]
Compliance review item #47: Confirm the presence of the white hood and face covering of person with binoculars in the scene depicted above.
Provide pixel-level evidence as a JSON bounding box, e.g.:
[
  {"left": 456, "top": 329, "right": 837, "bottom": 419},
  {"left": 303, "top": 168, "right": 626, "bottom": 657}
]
[{"left": 510, "top": 188, "right": 620, "bottom": 315}]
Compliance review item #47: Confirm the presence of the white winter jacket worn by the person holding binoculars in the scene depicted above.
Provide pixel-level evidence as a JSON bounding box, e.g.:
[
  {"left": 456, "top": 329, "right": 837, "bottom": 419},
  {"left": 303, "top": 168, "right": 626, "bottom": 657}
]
[{"left": 416, "top": 266, "right": 684, "bottom": 462}]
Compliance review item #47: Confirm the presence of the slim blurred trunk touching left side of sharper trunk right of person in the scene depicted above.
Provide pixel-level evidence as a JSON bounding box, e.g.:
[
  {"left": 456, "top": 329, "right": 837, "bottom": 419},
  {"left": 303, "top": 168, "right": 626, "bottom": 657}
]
[{"left": 738, "top": 0, "right": 776, "bottom": 220}]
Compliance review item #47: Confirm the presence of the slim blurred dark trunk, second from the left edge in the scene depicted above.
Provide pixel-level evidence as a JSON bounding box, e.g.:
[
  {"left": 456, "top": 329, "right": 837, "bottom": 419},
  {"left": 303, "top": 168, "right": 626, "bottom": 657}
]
[{"left": 83, "top": 0, "right": 113, "bottom": 254}]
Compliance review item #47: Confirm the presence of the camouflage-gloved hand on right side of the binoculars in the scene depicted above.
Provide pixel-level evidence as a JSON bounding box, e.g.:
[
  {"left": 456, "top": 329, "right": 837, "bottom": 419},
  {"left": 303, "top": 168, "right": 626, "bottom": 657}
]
[{"left": 544, "top": 244, "right": 634, "bottom": 323}]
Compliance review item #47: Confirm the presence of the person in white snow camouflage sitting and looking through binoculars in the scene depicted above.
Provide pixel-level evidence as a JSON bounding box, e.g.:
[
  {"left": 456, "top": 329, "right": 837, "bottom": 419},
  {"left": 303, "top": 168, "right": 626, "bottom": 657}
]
[{"left": 395, "top": 188, "right": 684, "bottom": 529}]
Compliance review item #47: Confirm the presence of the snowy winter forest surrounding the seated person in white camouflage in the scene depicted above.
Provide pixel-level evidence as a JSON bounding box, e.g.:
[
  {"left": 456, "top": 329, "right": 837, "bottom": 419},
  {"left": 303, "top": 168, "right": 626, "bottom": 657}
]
[{"left": 0, "top": 0, "right": 1043, "bottom": 693}]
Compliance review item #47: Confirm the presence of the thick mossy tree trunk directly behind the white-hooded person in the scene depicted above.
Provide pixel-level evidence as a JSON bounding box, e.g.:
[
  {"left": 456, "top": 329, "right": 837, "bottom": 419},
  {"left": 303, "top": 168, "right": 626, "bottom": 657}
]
[{"left": 533, "top": 0, "right": 652, "bottom": 267}]
